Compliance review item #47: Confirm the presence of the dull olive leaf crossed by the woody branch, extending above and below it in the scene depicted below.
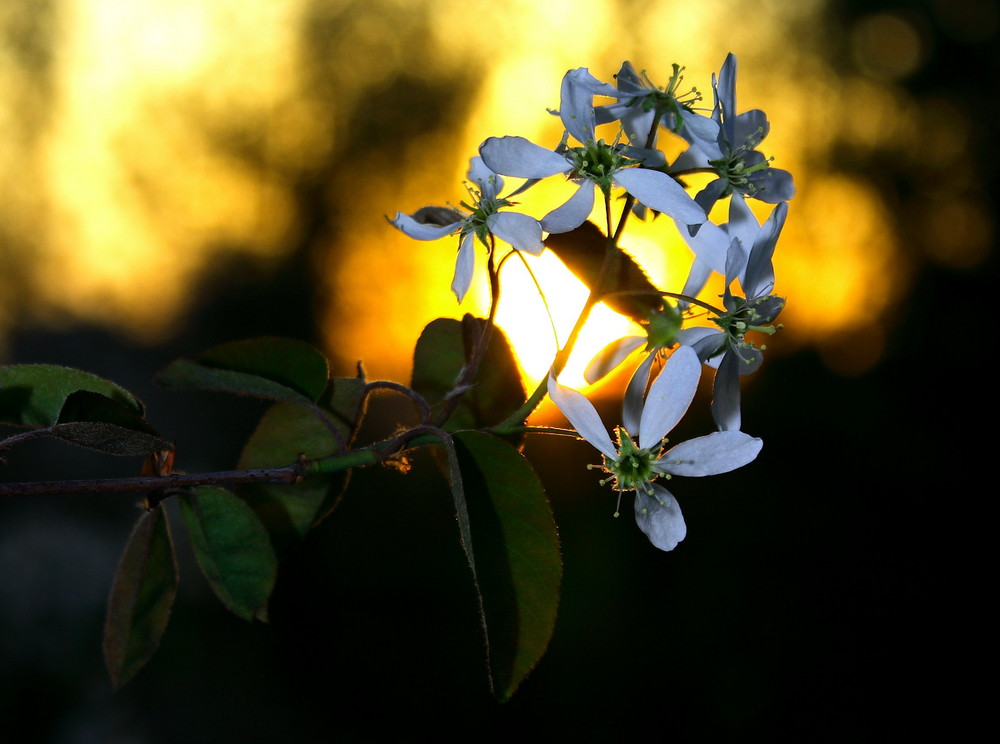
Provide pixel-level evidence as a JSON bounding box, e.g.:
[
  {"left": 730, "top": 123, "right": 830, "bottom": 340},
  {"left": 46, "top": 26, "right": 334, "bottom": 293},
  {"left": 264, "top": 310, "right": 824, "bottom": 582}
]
[{"left": 237, "top": 377, "right": 365, "bottom": 552}]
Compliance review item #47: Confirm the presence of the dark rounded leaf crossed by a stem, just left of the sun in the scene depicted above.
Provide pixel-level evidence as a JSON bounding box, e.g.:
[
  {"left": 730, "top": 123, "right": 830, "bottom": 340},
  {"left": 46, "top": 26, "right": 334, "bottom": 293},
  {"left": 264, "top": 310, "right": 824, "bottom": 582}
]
[{"left": 411, "top": 315, "right": 525, "bottom": 431}]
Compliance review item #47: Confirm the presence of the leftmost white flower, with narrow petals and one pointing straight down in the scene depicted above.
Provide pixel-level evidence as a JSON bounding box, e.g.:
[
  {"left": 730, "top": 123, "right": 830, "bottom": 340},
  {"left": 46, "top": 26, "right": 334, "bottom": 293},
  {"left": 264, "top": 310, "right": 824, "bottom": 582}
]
[{"left": 392, "top": 155, "right": 545, "bottom": 302}]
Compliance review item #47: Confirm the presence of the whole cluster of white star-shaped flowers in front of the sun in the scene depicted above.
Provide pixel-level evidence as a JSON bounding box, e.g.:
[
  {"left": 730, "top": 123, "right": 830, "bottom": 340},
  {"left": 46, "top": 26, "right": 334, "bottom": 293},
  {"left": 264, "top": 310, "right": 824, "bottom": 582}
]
[{"left": 392, "top": 54, "right": 795, "bottom": 550}]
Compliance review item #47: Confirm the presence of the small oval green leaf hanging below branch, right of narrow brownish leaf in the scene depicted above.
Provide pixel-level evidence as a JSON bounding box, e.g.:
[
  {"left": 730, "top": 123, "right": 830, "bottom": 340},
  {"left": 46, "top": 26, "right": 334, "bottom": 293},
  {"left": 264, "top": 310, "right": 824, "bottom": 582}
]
[{"left": 179, "top": 486, "right": 278, "bottom": 621}]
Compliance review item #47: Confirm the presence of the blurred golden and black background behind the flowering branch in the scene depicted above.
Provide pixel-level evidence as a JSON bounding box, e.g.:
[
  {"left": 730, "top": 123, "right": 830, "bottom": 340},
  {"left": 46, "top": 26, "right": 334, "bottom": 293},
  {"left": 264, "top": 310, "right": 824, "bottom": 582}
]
[{"left": 0, "top": 0, "right": 1000, "bottom": 742}]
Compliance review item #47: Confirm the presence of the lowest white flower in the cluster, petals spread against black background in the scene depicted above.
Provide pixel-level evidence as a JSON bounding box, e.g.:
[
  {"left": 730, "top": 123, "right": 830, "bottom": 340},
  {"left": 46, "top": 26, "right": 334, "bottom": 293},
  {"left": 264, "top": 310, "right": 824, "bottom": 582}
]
[{"left": 548, "top": 346, "right": 763, "bottom": 550}]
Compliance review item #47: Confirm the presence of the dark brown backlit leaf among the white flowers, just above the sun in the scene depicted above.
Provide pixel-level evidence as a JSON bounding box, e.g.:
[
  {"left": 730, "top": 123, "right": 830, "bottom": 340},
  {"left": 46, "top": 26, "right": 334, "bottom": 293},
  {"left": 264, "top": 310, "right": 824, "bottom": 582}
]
[{"left": 545, "top": 222, "right": 663, "bottom": 323}]
